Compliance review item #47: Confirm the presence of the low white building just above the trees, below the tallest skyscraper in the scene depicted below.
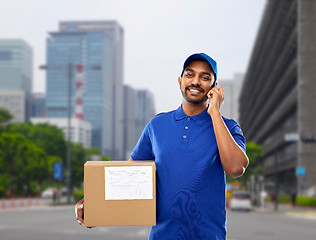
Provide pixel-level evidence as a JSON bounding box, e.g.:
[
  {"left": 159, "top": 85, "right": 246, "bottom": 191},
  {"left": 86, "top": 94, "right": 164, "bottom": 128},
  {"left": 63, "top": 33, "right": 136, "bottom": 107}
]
[{"left": 31, "top": 117, "right": 91, "bottom": 149}]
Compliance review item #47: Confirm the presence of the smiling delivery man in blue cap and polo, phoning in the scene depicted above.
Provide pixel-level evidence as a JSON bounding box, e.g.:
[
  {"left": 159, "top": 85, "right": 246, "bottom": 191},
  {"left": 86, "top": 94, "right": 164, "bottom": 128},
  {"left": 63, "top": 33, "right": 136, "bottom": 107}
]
[{"left": 75, "top": 53, "right": 249, "bottom": 240}]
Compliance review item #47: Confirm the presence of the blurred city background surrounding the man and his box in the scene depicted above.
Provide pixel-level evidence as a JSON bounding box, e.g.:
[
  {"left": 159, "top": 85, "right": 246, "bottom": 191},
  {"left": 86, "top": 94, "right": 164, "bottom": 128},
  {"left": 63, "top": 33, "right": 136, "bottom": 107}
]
[{"left": 0, "top": 0, "right": 316, "bottom": 240}]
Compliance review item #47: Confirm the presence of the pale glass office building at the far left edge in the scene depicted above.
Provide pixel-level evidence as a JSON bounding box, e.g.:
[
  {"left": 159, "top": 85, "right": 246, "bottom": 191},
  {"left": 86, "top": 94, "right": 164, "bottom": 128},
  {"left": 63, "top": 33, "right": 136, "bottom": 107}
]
[{"left": 0, "top": 39, "right": 33, "bottom": 121}]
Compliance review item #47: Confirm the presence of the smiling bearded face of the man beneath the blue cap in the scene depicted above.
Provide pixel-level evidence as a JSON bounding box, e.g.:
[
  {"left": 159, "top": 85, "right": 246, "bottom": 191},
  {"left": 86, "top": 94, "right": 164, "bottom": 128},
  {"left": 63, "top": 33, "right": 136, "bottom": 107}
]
[{"left": 178, "top": 61, "right": 215, "bottom": 105}]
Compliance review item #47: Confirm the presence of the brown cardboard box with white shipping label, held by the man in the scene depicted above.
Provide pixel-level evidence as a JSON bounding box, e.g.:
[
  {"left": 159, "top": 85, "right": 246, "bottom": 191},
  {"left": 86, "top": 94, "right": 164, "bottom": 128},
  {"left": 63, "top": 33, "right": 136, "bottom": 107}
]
[{"left": 84, "top": 161, "right": 156, "bottom": 227}]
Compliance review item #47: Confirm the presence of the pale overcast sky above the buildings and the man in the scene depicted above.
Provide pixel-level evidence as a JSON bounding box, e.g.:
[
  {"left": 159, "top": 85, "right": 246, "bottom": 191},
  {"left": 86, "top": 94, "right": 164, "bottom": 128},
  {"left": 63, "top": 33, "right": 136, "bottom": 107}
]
[{"left": 0, "top": 0, "right": 266, "bottom": 113}]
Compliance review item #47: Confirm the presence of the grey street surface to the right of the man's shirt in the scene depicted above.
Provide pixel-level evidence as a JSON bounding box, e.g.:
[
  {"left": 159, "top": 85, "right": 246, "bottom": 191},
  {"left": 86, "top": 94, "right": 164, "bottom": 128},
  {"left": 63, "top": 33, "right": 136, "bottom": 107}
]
[{"left": 227, "top": 211, "right": 316, "bottom": 240}]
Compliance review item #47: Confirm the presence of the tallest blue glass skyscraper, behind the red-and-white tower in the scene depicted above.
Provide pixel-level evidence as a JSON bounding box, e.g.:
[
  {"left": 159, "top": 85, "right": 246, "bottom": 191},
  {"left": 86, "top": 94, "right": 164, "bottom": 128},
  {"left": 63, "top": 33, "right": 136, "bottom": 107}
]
[{"left": 46, "top": 21, "right": 124, "bottom": 159}]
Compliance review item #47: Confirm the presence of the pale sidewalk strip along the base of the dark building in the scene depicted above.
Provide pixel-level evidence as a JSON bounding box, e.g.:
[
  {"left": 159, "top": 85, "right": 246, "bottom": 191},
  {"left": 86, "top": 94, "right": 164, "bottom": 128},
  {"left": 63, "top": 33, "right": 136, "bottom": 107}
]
[{"left": 254, "top": 202, "right": 316, "bottom": 221}]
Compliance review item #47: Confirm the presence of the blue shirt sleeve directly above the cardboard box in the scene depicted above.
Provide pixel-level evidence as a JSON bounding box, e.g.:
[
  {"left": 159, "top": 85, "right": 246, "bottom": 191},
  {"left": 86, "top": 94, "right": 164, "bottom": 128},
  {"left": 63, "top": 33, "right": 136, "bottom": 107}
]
[{"left": 131, "top": 122, "right": 155, "bottom": 160}]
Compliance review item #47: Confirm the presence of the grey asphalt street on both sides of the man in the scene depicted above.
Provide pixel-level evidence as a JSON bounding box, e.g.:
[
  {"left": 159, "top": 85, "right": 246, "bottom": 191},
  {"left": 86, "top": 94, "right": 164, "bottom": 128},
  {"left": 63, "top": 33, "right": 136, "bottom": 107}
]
[{"left": 0, "top": 205, "right": 316, "bottom": 240}]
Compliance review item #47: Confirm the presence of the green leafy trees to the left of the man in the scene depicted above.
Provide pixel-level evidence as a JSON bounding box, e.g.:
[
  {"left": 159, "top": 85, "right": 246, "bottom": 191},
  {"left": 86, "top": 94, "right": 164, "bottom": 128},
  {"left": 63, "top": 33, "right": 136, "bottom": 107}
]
[{"left": 0, "top": 120, "right": 111, "bottom": 196}]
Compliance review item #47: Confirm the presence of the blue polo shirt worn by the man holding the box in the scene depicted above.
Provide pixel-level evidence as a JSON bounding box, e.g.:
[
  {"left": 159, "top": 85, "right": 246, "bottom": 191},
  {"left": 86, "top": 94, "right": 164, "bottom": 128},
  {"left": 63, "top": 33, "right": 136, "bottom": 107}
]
[{"left": 131, "top": 106, "right": 245, "bottom": 240}]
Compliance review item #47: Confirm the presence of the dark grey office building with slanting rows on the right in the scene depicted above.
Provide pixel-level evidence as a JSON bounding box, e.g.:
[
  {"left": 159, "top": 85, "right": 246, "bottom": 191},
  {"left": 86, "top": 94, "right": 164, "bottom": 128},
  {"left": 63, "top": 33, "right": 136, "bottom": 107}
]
[{"left": 240, "top": 0, "right": 316, "bottom": 195}]
